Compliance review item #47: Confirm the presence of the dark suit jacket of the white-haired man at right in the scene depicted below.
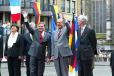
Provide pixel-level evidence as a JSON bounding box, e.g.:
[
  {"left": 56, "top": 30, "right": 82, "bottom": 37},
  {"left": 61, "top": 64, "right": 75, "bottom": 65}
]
[{"left": 77, "top": 26, "right": 97, "bottom": 60}]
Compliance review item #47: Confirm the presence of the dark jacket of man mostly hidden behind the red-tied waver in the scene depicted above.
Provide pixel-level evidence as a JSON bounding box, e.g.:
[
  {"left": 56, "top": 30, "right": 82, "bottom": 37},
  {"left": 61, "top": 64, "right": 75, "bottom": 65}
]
[{"left": 23, "top": 33, "right": 32, "bottom": 55}]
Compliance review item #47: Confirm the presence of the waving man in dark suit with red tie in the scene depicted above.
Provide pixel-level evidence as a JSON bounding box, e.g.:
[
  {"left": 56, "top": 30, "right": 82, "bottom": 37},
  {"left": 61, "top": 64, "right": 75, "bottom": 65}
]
[{"left": 23, "top": 12, "right": 51, "bottom": 76}]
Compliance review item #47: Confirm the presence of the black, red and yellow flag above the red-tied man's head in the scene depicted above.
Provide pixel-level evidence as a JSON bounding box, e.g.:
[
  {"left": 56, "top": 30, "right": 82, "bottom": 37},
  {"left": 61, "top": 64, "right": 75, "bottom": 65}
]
[{"left": 33, "top": 2, "right": 41, "bottom": 26}]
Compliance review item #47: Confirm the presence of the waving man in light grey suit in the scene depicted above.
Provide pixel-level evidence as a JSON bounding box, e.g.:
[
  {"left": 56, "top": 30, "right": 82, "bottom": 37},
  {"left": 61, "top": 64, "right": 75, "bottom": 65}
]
[{"left": 51, "top": 18, "right": 72, "bottom": 76}]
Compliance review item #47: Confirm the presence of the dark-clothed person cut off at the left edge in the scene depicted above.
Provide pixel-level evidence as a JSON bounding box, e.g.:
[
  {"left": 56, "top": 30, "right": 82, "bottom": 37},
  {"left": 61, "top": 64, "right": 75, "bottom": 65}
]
[{"left": 0, "top": 27, "right": 3, "bottom": 76}]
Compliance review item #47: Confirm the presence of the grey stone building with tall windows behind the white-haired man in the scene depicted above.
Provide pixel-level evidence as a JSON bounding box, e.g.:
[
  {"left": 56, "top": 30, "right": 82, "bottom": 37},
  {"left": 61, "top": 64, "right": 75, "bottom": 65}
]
[{"left": 81, "top": 0, "right": 114, "bottom": 51}]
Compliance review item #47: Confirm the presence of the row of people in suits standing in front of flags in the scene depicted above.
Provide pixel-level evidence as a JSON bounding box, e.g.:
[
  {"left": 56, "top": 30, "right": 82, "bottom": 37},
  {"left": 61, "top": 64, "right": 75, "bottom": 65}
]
[{"left": 0, "top": 12, "right": 108, "bottom": 76}]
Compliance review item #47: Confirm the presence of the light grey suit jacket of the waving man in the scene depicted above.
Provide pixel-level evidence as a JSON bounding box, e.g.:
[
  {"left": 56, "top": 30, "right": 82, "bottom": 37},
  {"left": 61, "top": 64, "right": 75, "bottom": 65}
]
[{"left": 52, "top": 23, "right": 72, "bottom": 59}]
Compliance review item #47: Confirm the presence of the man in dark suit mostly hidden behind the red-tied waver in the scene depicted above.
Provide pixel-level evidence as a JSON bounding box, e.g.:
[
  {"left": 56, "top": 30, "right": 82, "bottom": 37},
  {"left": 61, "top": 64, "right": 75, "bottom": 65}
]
[{"left": 23, "top": 23, "right": 35, "bottom": 76}]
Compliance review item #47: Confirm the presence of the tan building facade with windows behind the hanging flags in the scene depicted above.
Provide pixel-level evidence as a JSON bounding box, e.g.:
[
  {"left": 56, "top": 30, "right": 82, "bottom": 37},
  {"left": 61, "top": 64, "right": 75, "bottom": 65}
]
[{"left": 0, "top": 0, "right": 80, "bottom": 29}]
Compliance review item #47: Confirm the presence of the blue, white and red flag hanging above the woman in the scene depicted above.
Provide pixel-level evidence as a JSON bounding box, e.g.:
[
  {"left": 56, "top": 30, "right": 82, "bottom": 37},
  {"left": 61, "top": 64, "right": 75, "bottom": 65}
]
[{"left": 10, "top": 0, "right": 21, "bottom": 22}]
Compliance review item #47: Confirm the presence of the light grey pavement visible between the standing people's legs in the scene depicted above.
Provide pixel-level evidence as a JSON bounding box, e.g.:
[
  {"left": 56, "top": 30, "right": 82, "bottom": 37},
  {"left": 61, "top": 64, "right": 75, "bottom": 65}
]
[{"left": 1, "top": 62, "right": 111, "bottom": 76}]
